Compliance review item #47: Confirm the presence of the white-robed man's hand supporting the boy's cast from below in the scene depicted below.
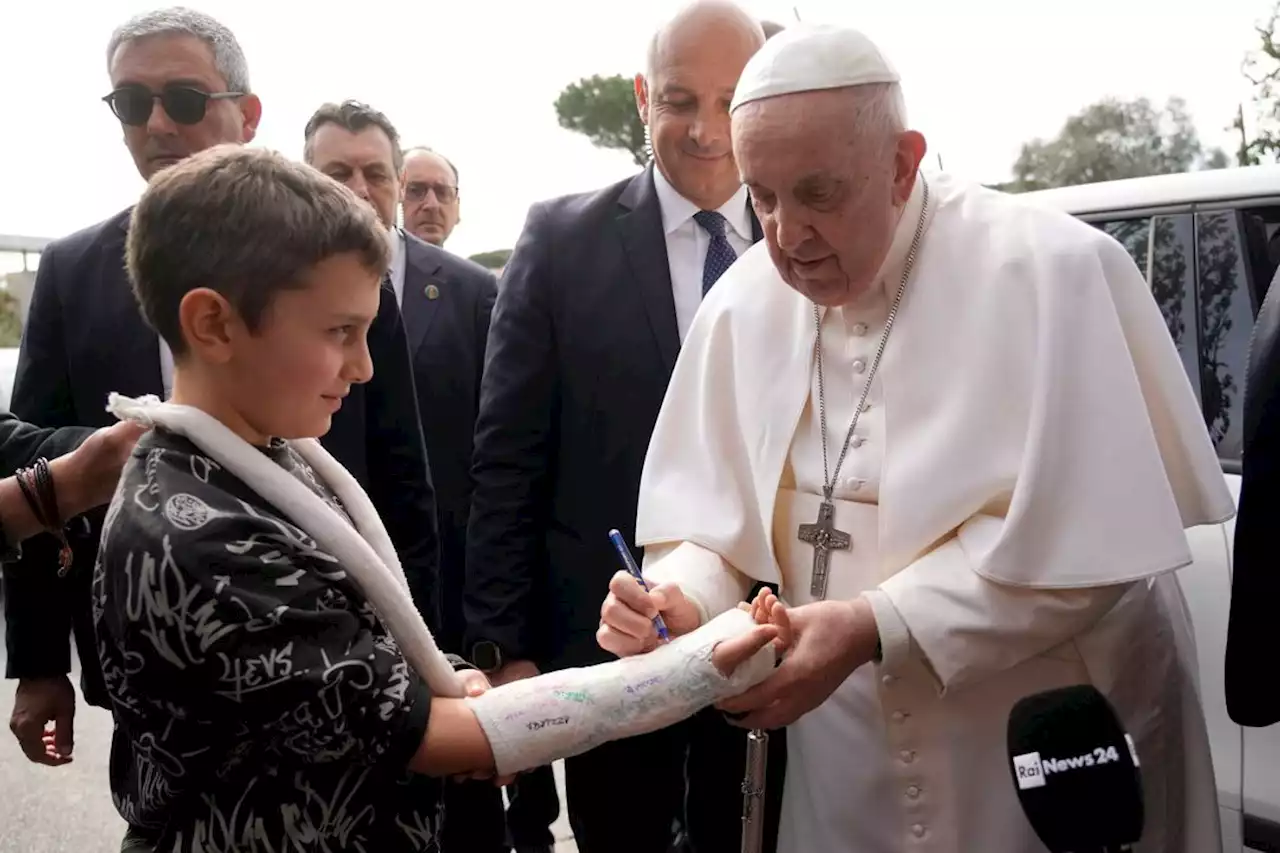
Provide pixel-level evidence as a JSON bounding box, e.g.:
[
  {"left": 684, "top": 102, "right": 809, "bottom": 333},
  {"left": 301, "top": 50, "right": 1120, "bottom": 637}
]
[{"left": 718, "top": 598, "right": 878, "bottom": 729}]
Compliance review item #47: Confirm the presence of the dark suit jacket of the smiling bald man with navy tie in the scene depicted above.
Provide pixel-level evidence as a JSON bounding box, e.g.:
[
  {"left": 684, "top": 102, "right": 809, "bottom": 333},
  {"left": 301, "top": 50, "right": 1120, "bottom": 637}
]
[{"left": 463, "top": 167, "right": 760, "bottom": 669}]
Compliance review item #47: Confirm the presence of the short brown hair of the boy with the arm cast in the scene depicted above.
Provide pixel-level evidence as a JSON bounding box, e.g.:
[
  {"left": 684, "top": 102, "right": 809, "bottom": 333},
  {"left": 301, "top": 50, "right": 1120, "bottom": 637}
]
[{"left": 125, "top": 145, "right": 389, "bottom": 356}]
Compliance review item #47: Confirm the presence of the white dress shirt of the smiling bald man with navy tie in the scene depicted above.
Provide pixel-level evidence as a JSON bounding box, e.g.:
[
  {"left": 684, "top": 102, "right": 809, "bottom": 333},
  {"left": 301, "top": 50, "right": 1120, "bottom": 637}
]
[{"left": 653, "top": 167, "right": 753, "bottom": 342}]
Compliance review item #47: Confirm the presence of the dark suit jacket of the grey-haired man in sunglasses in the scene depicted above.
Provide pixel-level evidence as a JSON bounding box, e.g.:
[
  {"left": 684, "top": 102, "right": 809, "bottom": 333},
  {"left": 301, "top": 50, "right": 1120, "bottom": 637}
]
[{"left": 5, "top": 210, "right": 439, "bottom": 703}]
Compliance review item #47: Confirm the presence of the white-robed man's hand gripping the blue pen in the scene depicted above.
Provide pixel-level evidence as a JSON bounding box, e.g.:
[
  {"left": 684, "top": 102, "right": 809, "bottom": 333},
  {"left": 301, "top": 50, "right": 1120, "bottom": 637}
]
[{"left": 595, "top": 571, "right": 701, "bottom": 657}]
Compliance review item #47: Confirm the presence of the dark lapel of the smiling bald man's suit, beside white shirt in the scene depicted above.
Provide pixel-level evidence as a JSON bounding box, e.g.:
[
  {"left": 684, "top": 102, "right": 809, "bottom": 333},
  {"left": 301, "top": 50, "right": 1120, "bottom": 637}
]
[{"left": 618, "top": 165, "right": 680, "bottom": 371}]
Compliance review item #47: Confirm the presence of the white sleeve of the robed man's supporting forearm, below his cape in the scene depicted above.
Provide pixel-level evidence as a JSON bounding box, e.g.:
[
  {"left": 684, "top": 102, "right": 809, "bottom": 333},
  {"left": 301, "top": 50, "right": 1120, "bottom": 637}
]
[{"left": 864, "top": 539, "right": 1140, "bottom": 692}]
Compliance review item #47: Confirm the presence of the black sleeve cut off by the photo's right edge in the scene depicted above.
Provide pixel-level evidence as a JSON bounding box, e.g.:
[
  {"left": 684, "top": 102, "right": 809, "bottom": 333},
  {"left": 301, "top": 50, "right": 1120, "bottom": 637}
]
[{"left": 1226, "top": 266, "right": 1280, "bottom": 726}]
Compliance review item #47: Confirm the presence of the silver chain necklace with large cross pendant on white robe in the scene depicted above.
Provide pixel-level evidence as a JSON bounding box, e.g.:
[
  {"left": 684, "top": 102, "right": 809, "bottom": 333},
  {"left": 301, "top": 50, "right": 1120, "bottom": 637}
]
[{"left": 797, "top": 175, "right": 929, "bottom": 599}]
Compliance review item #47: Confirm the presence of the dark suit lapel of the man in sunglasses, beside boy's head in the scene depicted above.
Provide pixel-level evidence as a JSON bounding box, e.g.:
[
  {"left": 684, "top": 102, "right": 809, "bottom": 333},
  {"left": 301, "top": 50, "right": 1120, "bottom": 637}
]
[{"left": 104, "top": 213, "right": 164, "bottom": 398}]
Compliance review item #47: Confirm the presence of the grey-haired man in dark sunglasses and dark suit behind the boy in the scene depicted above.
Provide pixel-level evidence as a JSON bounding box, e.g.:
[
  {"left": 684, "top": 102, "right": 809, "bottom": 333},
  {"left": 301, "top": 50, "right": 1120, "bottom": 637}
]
[{"left": 5, "top": 8, "right": 439, "bottom": 849}]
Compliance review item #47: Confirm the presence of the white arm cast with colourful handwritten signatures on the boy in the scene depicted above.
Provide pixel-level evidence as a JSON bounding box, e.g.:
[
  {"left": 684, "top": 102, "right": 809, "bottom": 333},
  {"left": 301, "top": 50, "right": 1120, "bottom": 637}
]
[{"left": 467, "top": 608, "right": 776, "bottom": 776}]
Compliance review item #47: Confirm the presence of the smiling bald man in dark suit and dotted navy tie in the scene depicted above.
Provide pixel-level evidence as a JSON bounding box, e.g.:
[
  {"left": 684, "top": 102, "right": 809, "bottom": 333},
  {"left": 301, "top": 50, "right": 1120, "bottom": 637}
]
[{"left": 463, "top": 1, "right": 782, "bottom": 853}]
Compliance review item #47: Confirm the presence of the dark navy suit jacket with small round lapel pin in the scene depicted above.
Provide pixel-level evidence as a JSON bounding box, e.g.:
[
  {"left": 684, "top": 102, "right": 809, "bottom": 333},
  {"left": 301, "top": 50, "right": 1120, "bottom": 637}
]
[{"left": 401, "top": 234, "right": 498, "bottom": 649}]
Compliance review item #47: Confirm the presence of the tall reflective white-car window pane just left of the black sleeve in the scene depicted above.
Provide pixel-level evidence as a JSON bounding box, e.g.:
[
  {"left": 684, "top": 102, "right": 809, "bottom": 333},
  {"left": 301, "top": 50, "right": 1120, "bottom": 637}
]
[{"left": 1196, "top": 210, "right": 1253, "bottom": 461}]
